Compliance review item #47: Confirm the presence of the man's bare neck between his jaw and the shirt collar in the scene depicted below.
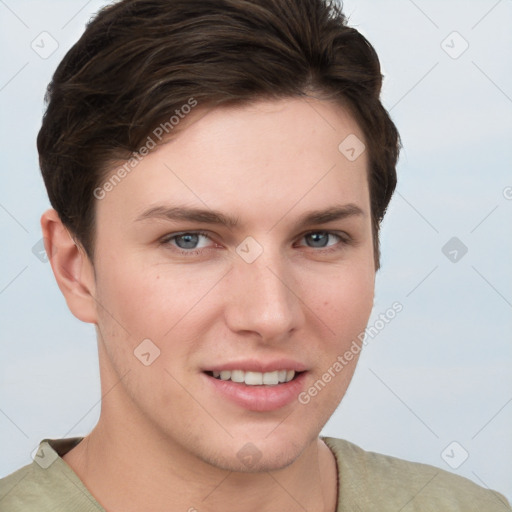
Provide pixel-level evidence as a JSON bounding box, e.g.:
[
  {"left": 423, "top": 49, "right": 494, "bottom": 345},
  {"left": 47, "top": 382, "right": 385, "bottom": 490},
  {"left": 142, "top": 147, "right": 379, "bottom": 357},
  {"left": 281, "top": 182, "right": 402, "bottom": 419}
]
[{"left": 63, "top": 346, "right": 338, "bottom": 512}]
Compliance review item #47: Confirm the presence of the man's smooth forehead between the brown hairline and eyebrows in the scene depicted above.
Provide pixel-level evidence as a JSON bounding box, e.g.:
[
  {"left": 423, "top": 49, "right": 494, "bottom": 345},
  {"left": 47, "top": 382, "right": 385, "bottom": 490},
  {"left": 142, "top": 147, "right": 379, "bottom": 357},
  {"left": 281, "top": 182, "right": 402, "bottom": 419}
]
[{"left": 98, "top": 98, "right": 368, "bottom": 227}]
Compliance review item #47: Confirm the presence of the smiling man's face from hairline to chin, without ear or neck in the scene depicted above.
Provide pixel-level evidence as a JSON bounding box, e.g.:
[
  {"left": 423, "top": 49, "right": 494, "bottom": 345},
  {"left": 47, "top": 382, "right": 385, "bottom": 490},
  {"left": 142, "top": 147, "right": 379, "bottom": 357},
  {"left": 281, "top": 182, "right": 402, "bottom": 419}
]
[{"left": 90, "top": 99, "right": 375, "bottom": 471}]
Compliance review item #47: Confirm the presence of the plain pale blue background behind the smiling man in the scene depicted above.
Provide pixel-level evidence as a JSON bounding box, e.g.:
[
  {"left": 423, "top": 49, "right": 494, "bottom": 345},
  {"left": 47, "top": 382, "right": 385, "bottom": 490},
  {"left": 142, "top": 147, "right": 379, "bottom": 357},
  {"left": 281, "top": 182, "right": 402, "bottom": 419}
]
[{"left": 0, "top": 0, "right": 512, "bottom": 500}]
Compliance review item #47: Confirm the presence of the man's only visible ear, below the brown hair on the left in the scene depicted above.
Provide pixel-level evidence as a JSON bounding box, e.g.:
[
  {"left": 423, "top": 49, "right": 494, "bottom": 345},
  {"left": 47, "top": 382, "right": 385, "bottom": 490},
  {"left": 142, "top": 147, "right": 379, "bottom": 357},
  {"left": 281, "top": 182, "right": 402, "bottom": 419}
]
[{"left": 41, "top": 209, "right": 97, "bottom": 324}]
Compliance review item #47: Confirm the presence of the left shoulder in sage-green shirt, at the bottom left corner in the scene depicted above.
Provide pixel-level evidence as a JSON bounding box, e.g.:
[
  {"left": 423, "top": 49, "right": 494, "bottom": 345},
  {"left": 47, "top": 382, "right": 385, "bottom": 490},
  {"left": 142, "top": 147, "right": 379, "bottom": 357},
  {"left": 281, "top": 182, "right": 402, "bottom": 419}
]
[{"left": 0, "top": 440, "right": 102, "bottom": 512}]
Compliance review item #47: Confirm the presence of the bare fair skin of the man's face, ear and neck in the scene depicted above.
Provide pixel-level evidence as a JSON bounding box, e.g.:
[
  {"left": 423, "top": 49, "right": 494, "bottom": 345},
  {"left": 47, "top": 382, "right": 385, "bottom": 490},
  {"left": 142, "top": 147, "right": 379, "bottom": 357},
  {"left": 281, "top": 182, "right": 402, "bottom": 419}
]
[{"left": 42, "top": 98, "right": 375, "bottom": 512}]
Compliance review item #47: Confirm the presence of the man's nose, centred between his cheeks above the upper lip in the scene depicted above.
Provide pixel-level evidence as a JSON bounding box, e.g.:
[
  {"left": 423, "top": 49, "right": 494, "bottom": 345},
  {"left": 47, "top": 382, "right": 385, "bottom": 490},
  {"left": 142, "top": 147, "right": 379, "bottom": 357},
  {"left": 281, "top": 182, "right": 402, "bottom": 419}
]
[{"left": 225, "top": 247, "right": 304, "bottom": 342}]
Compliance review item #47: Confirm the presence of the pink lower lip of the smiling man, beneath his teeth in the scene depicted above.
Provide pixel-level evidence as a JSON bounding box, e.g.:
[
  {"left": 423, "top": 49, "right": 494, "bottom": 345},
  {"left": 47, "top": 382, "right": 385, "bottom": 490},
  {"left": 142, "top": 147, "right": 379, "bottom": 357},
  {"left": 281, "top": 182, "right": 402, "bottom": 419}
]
[{"left": 203, "top": 372, "right": 307, "bottom": 412}]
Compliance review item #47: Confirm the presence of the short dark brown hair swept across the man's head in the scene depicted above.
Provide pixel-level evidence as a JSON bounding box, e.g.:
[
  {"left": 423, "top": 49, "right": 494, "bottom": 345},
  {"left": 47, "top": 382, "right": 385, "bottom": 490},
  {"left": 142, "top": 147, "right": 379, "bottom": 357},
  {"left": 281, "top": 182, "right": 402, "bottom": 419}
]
[{"left": 37, "top": 0, "right": 400, "bottom": 269}]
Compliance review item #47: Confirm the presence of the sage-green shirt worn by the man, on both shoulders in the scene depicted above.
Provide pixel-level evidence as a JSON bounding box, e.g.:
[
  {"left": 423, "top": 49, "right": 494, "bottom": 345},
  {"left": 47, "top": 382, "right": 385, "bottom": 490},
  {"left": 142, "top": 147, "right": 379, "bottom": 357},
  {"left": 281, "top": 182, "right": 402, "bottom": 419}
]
[{"left": 0, "top": 437, "right": 512, "bottom": 512}]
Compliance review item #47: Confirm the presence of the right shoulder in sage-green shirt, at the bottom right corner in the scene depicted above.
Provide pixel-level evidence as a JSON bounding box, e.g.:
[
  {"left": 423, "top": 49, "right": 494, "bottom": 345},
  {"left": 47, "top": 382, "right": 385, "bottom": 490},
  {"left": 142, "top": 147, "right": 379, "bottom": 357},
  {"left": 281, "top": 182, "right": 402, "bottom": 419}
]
[{"left": 322, "top": 437, "right": 512, "bottom": 512}]
